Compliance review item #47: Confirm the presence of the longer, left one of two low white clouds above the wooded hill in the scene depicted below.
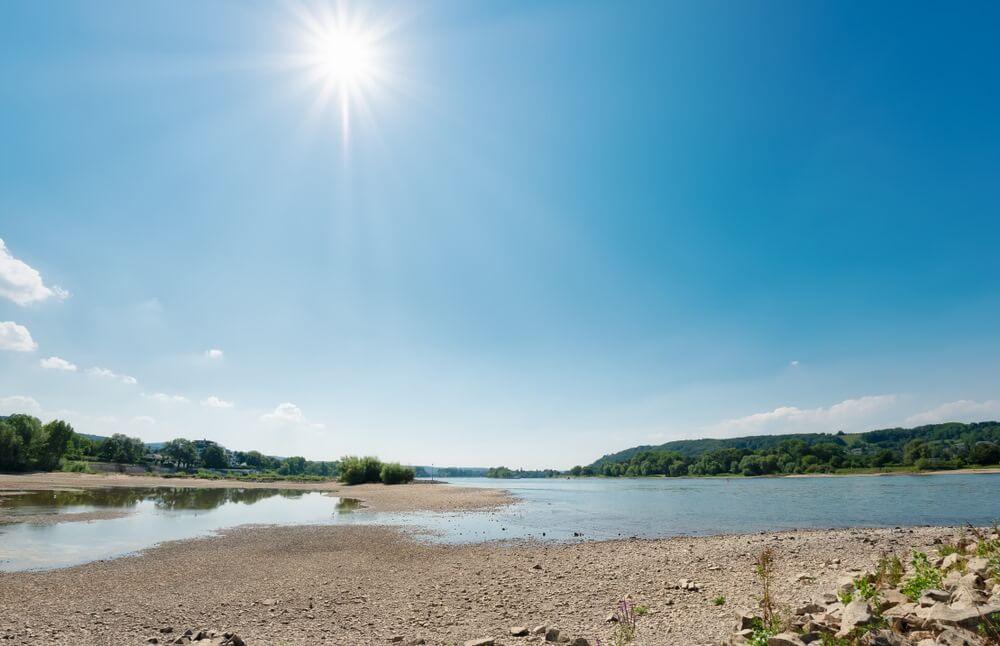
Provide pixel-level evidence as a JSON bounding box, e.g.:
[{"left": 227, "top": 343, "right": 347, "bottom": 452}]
[{"left": 708, "top": 395, "right": 899, "bottom": 435}]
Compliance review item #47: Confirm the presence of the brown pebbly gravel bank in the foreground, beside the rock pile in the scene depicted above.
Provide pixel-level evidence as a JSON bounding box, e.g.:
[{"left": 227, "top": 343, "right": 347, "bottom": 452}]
[{"left": 0, "top": 526, "right": 954, "bottom": 646}]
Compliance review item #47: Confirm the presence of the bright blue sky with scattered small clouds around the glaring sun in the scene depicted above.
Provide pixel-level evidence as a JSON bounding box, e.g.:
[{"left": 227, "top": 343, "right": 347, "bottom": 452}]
[{"left": 0, "top": 0, "right": 1000, "bottom": 467}]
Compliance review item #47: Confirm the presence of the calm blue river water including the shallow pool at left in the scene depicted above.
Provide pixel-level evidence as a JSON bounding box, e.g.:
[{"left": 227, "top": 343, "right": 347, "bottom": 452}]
[{"left": 0, "top": 474, "right": 1000, "bottom": 571}]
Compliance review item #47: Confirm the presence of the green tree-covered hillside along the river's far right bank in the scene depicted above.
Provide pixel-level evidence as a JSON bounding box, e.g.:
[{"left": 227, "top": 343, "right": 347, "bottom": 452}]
[{"left": 569, "top": 422, "right": 1000, "bottom": 477}]
